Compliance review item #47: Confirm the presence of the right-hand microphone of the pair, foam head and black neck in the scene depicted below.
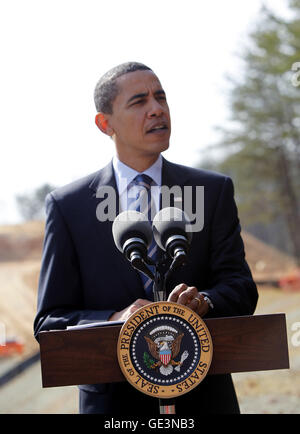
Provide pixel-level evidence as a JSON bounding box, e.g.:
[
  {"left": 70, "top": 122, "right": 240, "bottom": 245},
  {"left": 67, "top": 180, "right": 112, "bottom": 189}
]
[{"left": 152, "top": 207, "right": 192, "bottom": 270}]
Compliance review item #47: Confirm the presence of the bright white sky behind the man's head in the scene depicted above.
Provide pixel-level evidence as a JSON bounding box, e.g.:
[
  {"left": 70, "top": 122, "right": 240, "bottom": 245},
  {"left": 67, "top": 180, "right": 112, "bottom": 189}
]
[{"left": 0, "top": 0, "right": 286, "bottom": 224}]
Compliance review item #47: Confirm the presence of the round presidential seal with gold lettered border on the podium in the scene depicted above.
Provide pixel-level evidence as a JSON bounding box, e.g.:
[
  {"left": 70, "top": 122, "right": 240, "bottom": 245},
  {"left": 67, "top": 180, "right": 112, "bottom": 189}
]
[{"left": 117, "top": 302, "right": 213, "bottom": 398}]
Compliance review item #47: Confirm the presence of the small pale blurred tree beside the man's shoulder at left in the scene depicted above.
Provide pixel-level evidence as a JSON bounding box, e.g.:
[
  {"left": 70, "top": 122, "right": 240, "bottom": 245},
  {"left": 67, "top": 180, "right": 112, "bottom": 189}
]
[{"left": 16, "top": 184, "right": 55, "bottom": 220}]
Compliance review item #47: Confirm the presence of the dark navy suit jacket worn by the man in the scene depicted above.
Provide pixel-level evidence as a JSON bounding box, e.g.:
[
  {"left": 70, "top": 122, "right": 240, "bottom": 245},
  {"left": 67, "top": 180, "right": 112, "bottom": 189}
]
[{"left": 34, "top": 159, "right": 257, "bottom": 415}]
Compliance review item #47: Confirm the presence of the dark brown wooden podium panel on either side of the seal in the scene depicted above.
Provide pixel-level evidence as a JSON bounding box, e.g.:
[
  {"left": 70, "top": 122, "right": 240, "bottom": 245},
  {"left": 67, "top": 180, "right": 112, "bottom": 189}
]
[{"left": 39, "top": 314, "right": 289, "bottom": 387}]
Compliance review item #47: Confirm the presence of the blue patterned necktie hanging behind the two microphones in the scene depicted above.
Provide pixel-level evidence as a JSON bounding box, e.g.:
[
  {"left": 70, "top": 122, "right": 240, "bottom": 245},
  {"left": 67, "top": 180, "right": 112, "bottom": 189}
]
[{"left": 128, "top": 173, "right": 157, "bottom": 301}]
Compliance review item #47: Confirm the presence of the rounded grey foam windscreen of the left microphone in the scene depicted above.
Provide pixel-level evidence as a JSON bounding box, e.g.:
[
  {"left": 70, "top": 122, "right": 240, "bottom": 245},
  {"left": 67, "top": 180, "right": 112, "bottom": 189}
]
[{"left": 112, "top": 210, "right": 152, "bottom": 253}]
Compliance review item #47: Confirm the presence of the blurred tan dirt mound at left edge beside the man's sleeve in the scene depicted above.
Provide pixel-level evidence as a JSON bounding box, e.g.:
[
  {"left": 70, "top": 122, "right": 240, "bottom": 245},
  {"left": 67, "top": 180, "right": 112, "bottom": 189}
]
[{"left": 0, "top": 222, "right": 45, "bottom": 358}]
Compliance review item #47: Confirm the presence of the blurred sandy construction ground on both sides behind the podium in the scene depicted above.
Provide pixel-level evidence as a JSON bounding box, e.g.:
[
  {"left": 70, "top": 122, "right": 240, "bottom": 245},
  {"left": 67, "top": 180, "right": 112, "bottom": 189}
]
[{"left": 0, "top": 222, "right": 300, "bottom": 414}]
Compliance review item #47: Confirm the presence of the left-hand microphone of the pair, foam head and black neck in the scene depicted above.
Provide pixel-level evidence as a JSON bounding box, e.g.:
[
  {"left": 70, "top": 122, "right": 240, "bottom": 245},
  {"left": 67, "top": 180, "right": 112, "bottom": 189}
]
[{"left": 112, "top": 210, "right": 154, "bottom": 279}]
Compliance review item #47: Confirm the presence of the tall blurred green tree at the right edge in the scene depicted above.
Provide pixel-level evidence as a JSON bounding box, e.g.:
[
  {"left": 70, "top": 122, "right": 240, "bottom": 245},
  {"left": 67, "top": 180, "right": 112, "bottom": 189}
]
[{"left": 202, "top": 0, "right": 300, "bottom": 262}]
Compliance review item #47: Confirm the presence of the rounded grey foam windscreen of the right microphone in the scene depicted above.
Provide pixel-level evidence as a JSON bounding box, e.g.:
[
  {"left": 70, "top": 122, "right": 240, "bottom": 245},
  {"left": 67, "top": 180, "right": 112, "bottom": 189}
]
[{"left": 152, "top": 207, "right": 192, "bottom": 250}]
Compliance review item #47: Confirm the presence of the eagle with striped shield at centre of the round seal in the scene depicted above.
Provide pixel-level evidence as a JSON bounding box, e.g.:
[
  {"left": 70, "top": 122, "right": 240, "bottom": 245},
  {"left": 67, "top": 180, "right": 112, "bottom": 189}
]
[{"left": 144, "top": 326, "right": 188, "bottom": 375}]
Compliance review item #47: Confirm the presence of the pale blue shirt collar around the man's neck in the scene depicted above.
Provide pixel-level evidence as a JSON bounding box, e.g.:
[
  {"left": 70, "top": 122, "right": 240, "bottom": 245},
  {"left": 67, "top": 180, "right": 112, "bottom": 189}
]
[{"left": 113, "top": 154, "right": 162, "bottom": 194}]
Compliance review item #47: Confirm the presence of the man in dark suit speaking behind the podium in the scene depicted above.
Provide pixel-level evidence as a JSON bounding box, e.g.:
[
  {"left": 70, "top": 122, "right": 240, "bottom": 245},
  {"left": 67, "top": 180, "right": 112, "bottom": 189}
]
[{"left": 34, "top": 62, "right": 257, "bottom": 415}]
